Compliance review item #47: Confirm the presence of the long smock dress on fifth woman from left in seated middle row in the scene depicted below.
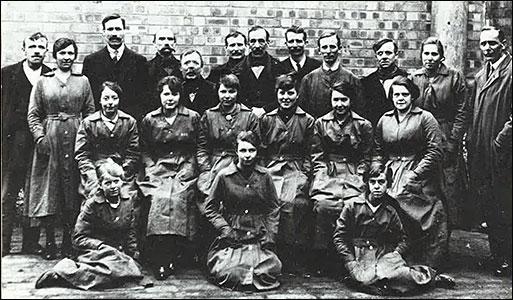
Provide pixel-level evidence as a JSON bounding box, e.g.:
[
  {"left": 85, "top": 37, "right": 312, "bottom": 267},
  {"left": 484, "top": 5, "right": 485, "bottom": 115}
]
[{"left": 310, "top": 111, "right": 373, "bottom": 250}]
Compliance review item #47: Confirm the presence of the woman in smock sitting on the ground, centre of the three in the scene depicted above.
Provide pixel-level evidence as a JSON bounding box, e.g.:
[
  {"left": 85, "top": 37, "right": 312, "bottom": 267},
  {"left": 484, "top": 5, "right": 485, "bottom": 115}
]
[{"left": 205, "top": 131, "right": 281, "bottom": 291}]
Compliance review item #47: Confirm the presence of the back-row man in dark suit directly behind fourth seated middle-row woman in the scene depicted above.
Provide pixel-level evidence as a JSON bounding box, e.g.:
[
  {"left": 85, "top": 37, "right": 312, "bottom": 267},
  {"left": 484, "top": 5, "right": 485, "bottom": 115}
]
[{"left": 280, "top": 25, "right": 321, "bottom": 91}]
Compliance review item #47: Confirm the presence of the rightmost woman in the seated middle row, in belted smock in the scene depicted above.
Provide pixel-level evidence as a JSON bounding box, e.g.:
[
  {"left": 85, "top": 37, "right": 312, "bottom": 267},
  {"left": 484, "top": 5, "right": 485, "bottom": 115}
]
[{"left": 375, "top": 76, "right": 447, "bottom": 269}]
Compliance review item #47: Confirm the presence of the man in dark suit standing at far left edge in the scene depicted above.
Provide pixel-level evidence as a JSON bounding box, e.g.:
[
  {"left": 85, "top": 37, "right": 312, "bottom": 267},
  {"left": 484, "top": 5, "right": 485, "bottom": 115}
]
[{"left": 2, "top": 32, "right": 51, "bottom": 256}]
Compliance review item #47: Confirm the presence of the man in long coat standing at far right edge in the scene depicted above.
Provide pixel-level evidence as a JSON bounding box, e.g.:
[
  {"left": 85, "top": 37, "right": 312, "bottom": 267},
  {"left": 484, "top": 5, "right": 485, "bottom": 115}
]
[{"left": 448, "top": 26, "right": 512, "bottom": 276}]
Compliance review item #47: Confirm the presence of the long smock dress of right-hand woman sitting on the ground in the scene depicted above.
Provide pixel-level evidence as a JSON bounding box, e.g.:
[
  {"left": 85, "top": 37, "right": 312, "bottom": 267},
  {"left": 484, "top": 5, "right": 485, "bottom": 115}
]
[{"left": 333, "top": 194, "right": 436, "bottom": 293}]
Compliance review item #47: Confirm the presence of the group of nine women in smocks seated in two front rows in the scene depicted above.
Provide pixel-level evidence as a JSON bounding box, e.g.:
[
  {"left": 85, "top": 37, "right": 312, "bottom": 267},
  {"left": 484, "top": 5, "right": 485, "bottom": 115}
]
[{"left": 36, "top": 75, "right": 454, "bottom": 292}]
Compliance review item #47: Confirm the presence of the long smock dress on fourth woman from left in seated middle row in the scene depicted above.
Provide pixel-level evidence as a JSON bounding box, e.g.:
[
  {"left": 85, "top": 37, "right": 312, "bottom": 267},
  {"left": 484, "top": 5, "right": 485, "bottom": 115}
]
[{"left": 260, "top": 107, "right": 315, "bottom": 252}]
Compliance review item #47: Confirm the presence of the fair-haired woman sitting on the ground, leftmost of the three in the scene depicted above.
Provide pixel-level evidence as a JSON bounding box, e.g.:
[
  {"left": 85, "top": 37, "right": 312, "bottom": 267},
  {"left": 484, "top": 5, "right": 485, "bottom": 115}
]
[{"left": 36, "top": 159, "right": 149, "bottom": 290}]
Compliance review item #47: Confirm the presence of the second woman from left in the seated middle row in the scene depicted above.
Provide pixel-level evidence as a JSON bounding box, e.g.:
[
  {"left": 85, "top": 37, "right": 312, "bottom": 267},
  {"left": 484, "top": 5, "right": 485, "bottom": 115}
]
[{"left": 138, "top": 76, "right": 200, "bottom": 280}]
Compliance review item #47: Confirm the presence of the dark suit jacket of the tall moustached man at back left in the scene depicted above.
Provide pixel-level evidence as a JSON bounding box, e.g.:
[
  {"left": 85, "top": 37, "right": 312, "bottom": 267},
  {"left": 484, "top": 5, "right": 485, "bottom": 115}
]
[{"left": 82, "top": 47, "right": 147, "bottom": 120}]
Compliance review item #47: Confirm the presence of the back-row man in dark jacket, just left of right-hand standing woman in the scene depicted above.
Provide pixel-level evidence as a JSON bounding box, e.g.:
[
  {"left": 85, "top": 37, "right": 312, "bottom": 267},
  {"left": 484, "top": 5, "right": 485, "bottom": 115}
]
[{"left": 361, "top": 38, "right": 408, "bottom": 127}]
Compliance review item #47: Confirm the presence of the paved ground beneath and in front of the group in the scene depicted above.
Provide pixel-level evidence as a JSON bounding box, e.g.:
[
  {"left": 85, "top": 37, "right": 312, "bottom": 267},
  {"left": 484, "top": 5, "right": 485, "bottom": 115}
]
[{"left": 1, "top": 229, "right": 512, "bottom": 299}]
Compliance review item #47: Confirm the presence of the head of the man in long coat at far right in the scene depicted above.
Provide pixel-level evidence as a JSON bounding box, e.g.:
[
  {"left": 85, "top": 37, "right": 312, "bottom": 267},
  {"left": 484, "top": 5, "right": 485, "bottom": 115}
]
[{"left": 479, "top": 26, "right": 507, "bottom": 63}]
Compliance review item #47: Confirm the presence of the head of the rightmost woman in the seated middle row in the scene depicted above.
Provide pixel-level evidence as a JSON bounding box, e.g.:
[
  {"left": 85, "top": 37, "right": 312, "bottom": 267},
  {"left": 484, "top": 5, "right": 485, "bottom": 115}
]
[{"left": 388, "top": 76, "right": 420, "bottom": 112}]
